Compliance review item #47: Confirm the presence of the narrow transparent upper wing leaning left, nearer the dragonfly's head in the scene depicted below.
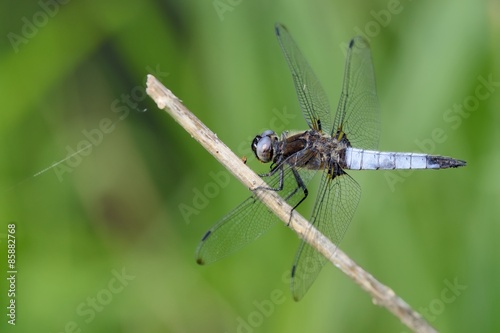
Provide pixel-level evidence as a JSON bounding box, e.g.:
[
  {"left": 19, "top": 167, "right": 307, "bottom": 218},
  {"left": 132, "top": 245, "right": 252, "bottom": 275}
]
[{"left": 275, "top": 23, "right": 331, "bottom": 133}]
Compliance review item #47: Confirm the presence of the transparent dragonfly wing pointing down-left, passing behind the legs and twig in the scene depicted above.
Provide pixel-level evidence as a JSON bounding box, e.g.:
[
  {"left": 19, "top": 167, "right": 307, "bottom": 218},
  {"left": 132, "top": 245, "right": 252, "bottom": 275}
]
[{"left": 196, "top": 156, "right": 315, "bottom": 265}]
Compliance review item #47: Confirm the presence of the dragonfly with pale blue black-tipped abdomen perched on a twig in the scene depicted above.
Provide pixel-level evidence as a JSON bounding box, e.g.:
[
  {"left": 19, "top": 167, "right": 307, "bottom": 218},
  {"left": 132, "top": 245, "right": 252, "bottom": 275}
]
[{"left": 196, "top": 23, "right": 466, "bottom": 301}]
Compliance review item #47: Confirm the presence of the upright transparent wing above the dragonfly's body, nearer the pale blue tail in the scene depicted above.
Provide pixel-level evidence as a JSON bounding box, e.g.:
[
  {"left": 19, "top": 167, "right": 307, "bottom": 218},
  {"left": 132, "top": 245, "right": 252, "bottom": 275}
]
[{"left": 332, "top": 36, "right": 380, "bottom": 149}]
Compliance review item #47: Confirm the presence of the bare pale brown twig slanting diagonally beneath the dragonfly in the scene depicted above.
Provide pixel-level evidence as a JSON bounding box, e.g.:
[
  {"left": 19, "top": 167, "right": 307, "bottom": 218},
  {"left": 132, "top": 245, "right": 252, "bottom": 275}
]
[{"left": 146, "top": 75, "right": 437, "bottom": 333}]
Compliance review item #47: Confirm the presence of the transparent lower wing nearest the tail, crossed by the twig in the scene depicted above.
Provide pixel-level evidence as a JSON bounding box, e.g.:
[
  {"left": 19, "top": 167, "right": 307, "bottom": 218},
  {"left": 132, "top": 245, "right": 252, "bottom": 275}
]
[{"left": 291, "top": 171, "right": 361, "bottom": 301}]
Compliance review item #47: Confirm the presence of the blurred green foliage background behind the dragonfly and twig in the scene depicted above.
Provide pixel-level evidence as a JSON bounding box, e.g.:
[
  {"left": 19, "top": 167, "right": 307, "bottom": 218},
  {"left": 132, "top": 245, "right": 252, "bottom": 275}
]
[{"left": 0, "top": 0, "right": 500, "bottom": 332}]
